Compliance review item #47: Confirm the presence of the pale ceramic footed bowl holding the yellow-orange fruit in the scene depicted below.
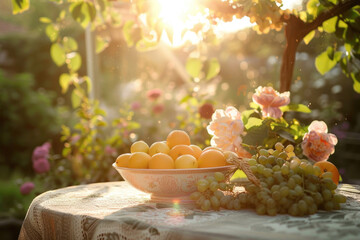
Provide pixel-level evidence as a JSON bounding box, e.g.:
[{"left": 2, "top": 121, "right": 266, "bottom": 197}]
[{"left": 113, "top": 163, "right": 235, "bottom": 202}]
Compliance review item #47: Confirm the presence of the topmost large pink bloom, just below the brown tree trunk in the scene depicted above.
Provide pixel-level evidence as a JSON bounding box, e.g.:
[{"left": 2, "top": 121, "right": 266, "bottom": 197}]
[{"left": 252, "top": 86, "right": 290, "bottom": 118}]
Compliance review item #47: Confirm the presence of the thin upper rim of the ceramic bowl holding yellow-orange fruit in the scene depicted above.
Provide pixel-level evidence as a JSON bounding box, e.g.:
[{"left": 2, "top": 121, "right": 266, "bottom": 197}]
[{"left": 112, "top": 162, "right": 236, "bottom": 174}]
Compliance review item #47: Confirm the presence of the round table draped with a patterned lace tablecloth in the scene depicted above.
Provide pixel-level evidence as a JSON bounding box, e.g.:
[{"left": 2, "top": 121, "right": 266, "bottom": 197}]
[{"left": 19, "top": 182, "right": 360, "bottom": 240}]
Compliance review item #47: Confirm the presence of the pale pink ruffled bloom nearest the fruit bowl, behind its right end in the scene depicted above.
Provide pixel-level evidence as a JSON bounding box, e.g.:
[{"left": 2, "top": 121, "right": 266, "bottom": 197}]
[{"left": 207, "top": 107, "right": 250, "bottom": 157}]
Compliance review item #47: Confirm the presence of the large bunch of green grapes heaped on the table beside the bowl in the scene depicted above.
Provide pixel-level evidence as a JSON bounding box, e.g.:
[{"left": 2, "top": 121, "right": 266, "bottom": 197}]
[{"left": 190, "top": 142, "right": 346, "bottom": 216}]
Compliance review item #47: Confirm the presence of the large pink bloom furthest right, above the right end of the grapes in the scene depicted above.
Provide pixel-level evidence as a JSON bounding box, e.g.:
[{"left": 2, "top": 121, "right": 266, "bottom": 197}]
[{"left": 301, "top": 121, "right": 338, "bottom": 162}]
